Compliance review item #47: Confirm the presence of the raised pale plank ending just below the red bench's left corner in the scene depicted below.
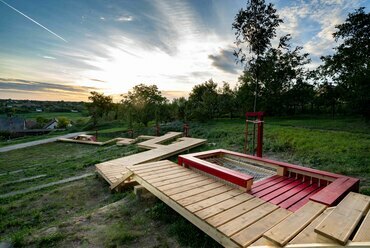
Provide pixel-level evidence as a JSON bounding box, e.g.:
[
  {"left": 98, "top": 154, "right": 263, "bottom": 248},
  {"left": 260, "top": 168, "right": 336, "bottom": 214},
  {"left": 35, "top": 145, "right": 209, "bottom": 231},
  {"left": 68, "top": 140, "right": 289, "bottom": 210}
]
[{"left": 263, "top": 201, "right": 326, "bottom": 246}]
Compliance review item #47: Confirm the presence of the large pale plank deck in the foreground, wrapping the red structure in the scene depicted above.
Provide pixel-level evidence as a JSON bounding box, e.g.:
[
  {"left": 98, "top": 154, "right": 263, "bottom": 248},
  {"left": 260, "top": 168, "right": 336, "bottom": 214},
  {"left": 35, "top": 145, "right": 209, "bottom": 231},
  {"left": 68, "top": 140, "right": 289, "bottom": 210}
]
[{"left": 125, "top": 160, "right": 370, "bottom": 247}]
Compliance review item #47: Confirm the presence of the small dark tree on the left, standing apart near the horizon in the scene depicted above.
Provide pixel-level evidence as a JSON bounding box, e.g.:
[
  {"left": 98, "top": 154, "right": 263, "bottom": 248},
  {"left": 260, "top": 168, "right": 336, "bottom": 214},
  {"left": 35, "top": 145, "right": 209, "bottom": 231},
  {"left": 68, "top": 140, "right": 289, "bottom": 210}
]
[{"left": 87, "top": 91, "right": 113, "bottom": 127}]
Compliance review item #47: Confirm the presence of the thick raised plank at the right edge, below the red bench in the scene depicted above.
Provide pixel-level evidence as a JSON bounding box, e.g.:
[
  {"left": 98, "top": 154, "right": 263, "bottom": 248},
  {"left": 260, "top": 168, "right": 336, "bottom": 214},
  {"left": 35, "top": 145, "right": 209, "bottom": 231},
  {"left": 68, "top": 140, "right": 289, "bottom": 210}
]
[{"left": 315, "top": 192, "right": 370, "bottom": 245}]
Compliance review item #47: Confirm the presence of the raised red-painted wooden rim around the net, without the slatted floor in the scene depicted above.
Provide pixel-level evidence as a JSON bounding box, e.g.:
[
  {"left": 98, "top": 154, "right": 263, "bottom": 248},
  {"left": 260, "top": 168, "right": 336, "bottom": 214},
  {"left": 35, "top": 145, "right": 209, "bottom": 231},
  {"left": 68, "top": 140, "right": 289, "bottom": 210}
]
[{"left": 178, "top": 149, "right": 360, "bottom": 206}]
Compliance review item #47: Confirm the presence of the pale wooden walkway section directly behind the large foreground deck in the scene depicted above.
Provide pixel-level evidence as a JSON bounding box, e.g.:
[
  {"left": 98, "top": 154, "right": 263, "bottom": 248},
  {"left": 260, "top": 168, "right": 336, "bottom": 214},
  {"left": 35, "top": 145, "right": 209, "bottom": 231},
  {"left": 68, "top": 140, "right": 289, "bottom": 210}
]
[{"left": 95, "top": 137, "right": 206, "bottom": 188}]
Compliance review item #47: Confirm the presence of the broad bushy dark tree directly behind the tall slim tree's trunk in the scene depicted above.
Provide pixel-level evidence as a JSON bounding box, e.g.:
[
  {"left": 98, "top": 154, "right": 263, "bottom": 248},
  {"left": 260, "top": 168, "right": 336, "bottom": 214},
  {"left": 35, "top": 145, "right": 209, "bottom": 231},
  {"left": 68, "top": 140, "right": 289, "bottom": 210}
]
[{"left": 238, "top": 35, "right": 310, "bottom": 115}]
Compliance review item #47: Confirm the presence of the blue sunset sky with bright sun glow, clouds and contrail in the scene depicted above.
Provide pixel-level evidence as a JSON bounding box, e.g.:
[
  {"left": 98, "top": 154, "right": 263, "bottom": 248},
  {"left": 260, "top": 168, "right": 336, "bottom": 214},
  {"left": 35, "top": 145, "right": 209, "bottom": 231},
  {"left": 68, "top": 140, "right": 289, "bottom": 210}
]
[{"left": 0, "top": 0, "right": 370, "bottom": 101}]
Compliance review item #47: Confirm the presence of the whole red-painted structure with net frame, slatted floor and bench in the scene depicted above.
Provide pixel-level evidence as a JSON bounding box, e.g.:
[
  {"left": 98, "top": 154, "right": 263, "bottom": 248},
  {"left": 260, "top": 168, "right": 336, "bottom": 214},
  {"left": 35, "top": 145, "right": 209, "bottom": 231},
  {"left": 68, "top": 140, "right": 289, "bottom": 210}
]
[{"left": 178, "top": 149, "right": 359, "bottom": 211}]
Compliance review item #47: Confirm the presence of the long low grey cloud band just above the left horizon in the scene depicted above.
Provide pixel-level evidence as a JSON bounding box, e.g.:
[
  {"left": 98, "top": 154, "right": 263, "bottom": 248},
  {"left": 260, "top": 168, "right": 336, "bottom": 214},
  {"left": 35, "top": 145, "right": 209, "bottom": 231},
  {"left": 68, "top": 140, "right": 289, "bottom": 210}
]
[{"left": 0, "top": 78, "right": 96, "bottom": 94}]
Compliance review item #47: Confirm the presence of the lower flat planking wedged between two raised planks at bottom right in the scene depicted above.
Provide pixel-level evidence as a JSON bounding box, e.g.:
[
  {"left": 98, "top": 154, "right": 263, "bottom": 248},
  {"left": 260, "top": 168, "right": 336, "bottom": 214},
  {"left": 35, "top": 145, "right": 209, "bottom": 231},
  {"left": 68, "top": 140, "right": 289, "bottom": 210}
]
[{"left": 289, "top": 208, "right": 339, "bottom": 245}]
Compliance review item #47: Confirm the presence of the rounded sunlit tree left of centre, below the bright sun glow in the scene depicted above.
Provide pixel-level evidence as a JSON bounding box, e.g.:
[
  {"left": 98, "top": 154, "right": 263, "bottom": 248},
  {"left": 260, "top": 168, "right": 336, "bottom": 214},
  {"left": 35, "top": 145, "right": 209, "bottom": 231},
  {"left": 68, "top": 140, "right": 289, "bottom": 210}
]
[{"left": 122, "top": 84, "right": 167, "bottom": 127}]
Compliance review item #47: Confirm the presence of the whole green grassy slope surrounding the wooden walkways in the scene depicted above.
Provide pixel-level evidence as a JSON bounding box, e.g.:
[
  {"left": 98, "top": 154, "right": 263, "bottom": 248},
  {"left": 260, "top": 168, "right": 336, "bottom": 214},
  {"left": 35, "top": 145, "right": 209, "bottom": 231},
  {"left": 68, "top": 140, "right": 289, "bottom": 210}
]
[{"left": 0, "top": 118, "right": 370, "bottom": 247}]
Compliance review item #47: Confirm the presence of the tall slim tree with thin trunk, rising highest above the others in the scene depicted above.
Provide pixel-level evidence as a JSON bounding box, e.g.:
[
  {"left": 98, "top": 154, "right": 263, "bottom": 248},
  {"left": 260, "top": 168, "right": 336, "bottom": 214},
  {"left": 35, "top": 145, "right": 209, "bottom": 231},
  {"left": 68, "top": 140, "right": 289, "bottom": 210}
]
[{"left": 232, "top": 0, "right": 283, "bottom": 111}]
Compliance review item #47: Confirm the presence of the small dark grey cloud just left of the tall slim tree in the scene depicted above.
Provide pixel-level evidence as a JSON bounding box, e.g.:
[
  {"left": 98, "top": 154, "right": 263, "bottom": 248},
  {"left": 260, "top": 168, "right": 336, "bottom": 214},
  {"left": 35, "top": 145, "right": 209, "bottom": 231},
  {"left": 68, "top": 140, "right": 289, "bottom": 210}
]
[{"left": 208, "top": 49, "right": 238, "bottom": 74}]
